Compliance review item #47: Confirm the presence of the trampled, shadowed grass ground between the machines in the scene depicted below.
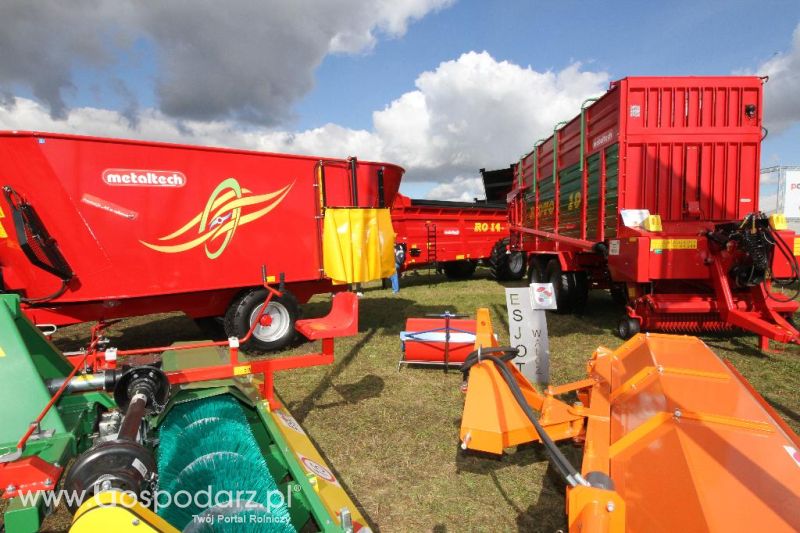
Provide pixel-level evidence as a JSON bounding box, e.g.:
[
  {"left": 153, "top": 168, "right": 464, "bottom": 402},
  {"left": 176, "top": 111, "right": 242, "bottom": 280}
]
[{"left": 34, "top": 270, "right": 800, "bottom": 532}]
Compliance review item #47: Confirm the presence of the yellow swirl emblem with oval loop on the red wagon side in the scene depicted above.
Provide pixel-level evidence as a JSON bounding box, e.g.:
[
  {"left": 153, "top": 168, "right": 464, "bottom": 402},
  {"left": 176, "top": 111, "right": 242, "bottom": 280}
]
[{"left": 139, "top": 178, "right": 294, "bottom": 259}]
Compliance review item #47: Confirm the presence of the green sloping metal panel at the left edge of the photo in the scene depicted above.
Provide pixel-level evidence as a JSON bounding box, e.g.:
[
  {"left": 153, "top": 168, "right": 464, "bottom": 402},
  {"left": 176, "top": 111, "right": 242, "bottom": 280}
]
[{"left": 0, "top": 294, "right": 71, "bottom": 444}]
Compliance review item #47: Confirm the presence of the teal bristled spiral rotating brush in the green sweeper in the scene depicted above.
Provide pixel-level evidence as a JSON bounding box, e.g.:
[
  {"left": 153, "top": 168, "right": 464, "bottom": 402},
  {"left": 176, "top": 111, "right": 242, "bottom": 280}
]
[{"left": 158, "top": 395, "right": 295, "bottom": 532}]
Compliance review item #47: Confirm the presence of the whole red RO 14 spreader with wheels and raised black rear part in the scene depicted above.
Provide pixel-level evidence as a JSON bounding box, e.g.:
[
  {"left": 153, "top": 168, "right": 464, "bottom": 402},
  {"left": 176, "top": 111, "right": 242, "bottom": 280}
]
[{"left": 392, "top": 167, "right": 525, "bottom": 280}]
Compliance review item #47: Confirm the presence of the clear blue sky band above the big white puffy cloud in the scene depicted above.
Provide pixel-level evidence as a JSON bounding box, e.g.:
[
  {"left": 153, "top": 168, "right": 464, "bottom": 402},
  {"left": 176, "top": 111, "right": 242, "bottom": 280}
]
[{"left": 297, "top": 0, "right": 800, "bottom": 128}]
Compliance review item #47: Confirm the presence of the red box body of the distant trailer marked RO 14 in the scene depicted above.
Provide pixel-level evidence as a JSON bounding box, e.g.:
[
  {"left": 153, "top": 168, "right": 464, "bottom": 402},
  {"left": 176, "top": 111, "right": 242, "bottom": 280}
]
[{"left": 392, "top": 194, "right": 508, "bottom": 279}]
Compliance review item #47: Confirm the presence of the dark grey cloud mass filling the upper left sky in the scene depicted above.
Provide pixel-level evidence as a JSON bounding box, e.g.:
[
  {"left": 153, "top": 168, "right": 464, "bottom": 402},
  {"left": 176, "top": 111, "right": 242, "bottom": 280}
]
[{"left": 0, "top": 0, "right": 453, "bottom": 126}]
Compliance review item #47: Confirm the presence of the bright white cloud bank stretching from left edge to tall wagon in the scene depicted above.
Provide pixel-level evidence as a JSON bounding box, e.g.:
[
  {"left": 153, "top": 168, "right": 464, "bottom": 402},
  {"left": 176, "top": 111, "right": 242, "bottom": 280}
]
[{"left": 0, "top": 50, "right": 609, "bottom": 199}]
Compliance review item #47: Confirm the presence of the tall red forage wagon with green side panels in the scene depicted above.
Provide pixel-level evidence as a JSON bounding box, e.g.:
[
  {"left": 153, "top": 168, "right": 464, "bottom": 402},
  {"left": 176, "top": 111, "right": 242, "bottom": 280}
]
[{"left": 508, "top": 76, "right": 800, "bottom": 349}]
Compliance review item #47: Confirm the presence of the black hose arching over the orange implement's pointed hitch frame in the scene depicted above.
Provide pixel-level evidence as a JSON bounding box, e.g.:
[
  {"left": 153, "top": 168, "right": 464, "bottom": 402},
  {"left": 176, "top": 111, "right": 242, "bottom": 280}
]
[{"left": 461, "top": 346, "right": 589, "bottom": 487}]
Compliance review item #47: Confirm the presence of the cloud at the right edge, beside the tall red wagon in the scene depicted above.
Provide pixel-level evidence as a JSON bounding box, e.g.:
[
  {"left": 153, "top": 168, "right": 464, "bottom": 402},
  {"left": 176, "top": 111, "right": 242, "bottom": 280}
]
[{"left": 756, "top": 25, "right": 800, "bottom": 133}]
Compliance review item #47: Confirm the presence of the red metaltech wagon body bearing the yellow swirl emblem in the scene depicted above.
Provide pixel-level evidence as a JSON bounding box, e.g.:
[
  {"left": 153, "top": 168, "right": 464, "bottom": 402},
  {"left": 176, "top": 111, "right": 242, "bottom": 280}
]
[{"left": 0, "top": 132, "right": 403, "bottom": 350}]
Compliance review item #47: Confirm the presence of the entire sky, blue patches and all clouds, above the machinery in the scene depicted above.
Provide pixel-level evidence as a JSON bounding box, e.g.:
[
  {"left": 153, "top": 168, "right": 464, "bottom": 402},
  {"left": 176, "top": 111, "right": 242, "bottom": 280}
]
[{"left": 0, "top": 0, "right": 800, "bottom": 199}]
